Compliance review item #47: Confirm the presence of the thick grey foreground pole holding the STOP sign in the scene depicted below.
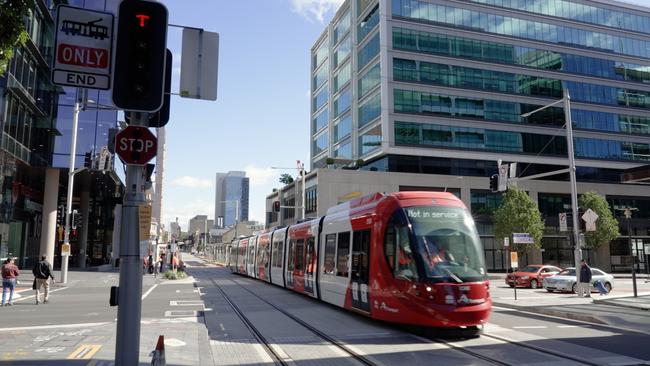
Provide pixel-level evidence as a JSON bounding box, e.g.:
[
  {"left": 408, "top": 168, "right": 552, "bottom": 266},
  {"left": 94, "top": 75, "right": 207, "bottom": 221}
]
[{"left": 115, "top": 113, "right": 149, "bottom": 366}]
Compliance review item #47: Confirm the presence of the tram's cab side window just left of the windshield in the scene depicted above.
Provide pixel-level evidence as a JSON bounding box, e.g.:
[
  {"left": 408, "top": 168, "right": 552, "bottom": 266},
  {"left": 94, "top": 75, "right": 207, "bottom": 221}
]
[{"left": 384, "top": 218, "right": 417, "bottom": 281}]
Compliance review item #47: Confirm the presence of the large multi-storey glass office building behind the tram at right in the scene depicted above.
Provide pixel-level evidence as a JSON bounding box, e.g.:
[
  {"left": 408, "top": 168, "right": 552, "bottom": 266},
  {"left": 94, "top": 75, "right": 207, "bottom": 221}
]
[{"left": 310, "top": 0, "right": 650, "bottom": 271}]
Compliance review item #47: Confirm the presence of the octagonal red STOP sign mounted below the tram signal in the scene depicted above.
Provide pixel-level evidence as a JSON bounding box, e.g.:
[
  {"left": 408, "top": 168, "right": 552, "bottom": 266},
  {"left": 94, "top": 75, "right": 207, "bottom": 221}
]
[{"left": 115, "top": 126, "right": 158, "bottom": 165}]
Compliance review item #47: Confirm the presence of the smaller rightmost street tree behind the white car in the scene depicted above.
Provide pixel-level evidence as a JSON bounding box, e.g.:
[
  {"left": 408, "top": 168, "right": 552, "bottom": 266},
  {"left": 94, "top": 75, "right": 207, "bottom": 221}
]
[{"left": 578, "top": 191, "right": 620, "bottom": 248}]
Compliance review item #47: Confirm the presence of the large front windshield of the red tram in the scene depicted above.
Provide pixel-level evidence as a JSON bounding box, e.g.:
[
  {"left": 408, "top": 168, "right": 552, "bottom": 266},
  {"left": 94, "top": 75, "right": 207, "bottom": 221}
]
[{"left": 405, "top": 206, "right": 486, "bottom": 283}]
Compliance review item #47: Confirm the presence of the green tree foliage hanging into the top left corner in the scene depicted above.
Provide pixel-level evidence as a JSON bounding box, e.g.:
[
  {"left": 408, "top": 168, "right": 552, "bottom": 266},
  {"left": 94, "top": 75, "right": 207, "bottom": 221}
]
[{"left": 0, "top": 0, "right": 35, "bottom": 76}]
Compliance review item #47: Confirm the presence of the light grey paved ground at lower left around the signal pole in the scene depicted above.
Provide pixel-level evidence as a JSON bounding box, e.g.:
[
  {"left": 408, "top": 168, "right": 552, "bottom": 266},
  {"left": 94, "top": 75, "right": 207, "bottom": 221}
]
[{"left": 0, "top": 254, "right": 213, "bottom": 366}]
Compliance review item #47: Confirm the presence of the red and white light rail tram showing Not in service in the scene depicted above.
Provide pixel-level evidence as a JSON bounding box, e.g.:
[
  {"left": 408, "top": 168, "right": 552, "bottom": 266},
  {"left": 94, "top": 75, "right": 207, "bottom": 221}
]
[{"left": 227, "top": 192, "right": 492, "bottom": 328}]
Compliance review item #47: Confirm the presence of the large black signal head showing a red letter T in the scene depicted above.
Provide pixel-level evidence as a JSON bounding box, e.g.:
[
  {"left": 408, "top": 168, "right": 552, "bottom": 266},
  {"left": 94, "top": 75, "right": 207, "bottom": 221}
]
[{"left": 113, "top": 0, "right": 167, "bottom": 112}]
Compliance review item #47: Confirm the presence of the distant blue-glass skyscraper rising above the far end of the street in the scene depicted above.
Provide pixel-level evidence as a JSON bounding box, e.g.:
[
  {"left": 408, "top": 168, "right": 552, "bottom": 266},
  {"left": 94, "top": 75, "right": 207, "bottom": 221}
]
[{"left": 214, "top": 172, "right": 249, "bottom": 227}]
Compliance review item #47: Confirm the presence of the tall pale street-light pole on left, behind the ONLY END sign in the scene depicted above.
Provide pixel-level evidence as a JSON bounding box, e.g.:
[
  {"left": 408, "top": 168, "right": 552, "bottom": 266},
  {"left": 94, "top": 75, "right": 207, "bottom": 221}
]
[{"left": 61, "top": 88, "right": 84, "bottom": 283}]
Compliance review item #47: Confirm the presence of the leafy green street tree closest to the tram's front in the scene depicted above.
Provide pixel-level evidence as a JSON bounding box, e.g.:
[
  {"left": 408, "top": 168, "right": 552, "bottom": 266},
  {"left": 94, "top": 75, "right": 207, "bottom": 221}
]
[{"left": 492, "top": 187, "right": 544, "bottom": 252}]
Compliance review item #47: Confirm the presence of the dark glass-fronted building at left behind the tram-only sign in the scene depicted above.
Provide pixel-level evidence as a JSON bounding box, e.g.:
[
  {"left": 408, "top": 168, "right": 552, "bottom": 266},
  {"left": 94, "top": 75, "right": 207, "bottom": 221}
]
[{"left": 0, "top": 0, "right": 123, "bottom": 268}]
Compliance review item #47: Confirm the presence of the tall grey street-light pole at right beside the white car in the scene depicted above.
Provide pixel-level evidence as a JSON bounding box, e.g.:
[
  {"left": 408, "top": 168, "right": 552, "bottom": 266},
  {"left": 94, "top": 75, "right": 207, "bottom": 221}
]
[{"left": 564, "top": 89, "right": 582, "bottom": 284}]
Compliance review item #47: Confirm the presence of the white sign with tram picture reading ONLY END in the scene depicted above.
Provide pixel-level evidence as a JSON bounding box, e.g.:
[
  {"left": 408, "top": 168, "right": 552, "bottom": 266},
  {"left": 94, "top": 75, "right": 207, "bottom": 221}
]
[{"left": 52, "top": 5, "right": 113, "bottom": 90}]
